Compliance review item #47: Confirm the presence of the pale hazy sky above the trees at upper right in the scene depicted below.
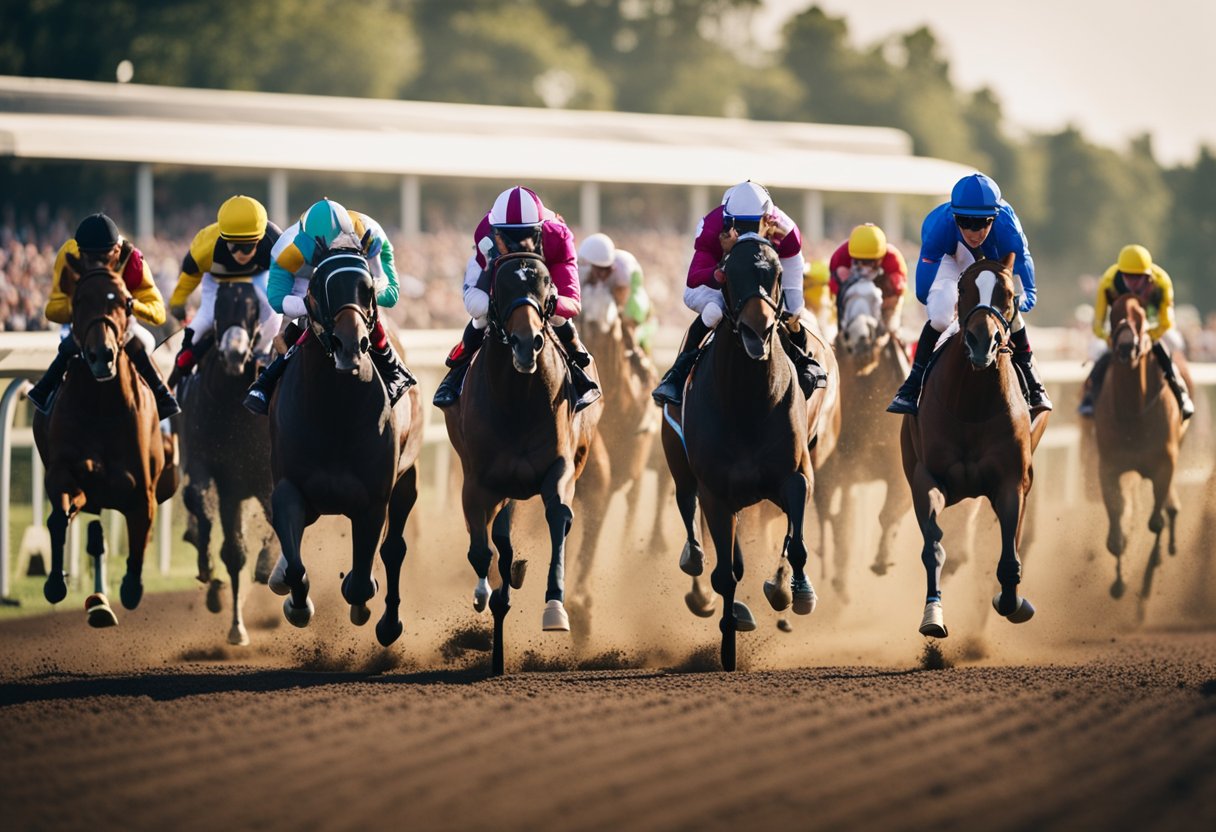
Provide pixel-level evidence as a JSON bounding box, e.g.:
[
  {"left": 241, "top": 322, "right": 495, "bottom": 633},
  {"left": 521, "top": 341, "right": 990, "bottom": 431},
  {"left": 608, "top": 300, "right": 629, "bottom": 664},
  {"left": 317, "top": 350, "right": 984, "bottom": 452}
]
[{"left": 758, "top": 0, "right": 1216, "bottom": 163}]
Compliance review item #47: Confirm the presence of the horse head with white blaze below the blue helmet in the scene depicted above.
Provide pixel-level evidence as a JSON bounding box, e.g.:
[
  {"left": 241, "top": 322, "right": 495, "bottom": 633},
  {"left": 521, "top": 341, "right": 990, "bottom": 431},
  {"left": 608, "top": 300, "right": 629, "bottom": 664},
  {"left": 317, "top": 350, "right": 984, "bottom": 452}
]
[{"left": 958, "top": 253, "right": 1017, "bottom": 370}]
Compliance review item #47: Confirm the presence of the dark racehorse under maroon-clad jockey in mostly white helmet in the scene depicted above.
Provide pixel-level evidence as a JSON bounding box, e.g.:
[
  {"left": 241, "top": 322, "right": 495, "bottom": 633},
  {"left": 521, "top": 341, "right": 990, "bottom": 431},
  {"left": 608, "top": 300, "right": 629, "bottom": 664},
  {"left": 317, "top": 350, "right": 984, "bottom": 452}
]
[{"left": 663, "top": 240, "right": 823, "bottom": 670}]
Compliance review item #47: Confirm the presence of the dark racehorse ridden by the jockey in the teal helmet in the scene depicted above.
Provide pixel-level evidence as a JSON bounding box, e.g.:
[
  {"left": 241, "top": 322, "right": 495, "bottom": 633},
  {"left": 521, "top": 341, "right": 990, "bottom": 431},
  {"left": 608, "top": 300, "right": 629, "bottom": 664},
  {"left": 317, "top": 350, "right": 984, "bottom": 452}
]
[{"left": 270, "top": 247, "right": 422, "bottom": 647}]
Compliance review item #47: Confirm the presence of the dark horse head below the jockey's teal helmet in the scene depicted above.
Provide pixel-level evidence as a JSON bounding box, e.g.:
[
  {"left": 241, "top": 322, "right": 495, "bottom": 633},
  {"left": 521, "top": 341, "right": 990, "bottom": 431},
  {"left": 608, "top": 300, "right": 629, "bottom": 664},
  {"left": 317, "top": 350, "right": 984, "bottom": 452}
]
[{"left": 305, "top": 248, "right": 378, "bottom": 382}]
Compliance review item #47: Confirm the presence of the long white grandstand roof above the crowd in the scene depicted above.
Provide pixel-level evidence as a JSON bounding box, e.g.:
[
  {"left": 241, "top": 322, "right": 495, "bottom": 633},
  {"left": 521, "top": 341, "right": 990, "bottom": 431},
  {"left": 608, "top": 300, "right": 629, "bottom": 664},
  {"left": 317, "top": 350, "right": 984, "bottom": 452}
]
[{"left": 0, "top": 75, "right": 970, "bottom": 196}]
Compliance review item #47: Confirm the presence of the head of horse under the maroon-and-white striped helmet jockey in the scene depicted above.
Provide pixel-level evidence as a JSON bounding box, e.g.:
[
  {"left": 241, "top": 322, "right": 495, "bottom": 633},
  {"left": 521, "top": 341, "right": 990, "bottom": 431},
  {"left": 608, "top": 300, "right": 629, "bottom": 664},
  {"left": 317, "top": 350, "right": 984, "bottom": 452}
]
[{"left": 490, "top": 253, "right": 556, "bottom": 373}]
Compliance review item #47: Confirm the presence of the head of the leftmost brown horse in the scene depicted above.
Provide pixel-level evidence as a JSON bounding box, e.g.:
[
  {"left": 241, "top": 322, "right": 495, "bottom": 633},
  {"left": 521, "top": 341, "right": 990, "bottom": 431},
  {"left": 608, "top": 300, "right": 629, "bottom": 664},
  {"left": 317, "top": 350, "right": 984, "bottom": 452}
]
[{"left": 60, "top": 253, "right": 135, "bottom": 381}]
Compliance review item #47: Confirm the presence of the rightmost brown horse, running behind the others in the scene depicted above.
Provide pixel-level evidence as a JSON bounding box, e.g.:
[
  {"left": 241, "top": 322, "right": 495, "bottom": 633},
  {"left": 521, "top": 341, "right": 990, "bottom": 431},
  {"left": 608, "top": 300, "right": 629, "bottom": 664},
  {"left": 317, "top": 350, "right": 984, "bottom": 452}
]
[{"left": 1093, "top": 294, "right": 1194, "bottom": 601}]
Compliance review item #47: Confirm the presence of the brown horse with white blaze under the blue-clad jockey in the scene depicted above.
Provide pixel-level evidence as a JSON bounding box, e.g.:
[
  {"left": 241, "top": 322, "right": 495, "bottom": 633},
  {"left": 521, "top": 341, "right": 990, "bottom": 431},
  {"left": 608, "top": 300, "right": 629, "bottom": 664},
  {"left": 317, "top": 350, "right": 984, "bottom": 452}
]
[{"left": 900, "top": 254, "right": 1047, "bottom": 639}]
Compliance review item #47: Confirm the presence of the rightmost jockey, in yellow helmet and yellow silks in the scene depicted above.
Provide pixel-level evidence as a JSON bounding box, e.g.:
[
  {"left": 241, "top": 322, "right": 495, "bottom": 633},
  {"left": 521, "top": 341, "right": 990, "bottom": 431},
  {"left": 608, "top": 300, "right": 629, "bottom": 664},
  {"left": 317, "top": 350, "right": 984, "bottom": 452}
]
[{"left": 1077, "top": 246, "right": 1195, "bottom": 421}]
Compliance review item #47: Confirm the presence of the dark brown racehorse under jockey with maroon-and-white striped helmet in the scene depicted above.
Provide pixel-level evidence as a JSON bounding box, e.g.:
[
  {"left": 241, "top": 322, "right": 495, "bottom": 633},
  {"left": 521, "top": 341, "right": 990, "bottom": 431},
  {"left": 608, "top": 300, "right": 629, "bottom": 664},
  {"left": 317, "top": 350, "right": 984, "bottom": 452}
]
[{"left": 444, "top": 253, "right": 603, "bottom": 675}]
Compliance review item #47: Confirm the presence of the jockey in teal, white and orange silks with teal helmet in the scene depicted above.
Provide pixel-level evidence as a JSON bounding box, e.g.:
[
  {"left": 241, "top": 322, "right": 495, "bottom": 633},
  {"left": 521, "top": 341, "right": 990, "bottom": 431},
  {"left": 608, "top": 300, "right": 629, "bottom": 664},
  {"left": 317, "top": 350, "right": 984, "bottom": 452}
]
[{"left": 244, "top": 197, "right": 417, "bottom": 415}]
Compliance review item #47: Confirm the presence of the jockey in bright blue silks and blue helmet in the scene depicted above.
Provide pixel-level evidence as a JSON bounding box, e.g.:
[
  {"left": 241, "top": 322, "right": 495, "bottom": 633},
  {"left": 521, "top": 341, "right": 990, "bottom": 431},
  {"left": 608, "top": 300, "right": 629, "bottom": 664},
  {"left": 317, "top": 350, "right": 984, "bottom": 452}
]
[{"left": 886, "top": 173, "right": 1052, "bottom": 414}]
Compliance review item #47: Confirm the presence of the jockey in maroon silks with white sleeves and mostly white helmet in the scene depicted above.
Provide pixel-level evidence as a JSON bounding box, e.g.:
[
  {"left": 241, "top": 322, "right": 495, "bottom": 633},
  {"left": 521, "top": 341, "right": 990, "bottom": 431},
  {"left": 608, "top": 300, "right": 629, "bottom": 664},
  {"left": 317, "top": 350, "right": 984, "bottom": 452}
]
[{"left": 651, "top": 180, "right": 822, "bottom": 407}]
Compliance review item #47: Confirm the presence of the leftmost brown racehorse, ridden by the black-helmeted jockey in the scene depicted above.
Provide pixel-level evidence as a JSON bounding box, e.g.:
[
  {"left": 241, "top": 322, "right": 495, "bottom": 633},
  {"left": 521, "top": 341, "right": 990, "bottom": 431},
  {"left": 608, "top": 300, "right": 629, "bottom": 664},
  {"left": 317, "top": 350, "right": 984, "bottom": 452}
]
[{"left": 34, "top": 254, "right": 178, "bottom": 626}]
